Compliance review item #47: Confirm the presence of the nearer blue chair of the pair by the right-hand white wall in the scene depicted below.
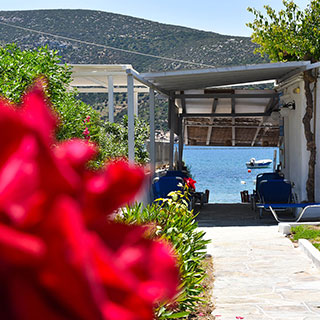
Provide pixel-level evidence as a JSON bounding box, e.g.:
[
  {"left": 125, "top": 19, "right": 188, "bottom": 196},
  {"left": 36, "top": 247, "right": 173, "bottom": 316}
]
[{"left": 258, "top": 179, "right": 294, "bottom": 218}]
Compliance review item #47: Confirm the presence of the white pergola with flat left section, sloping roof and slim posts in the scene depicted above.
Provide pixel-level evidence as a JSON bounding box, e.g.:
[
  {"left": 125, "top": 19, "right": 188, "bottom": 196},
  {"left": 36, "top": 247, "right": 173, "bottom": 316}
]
[{"left": 71, "top": 61, "right": 314, "bottom": 174}]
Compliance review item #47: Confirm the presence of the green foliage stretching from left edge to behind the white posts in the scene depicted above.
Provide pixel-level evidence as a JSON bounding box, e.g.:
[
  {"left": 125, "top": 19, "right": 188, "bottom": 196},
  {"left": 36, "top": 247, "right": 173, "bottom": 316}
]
[{"left": 0, "top": 44, "right": 149, "bottom": 167}]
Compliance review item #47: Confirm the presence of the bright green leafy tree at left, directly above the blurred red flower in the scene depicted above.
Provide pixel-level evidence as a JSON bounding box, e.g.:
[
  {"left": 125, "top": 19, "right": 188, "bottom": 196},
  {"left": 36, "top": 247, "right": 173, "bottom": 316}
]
[{"left": 0, "top": 44, "right": 100, "bottom": 140}]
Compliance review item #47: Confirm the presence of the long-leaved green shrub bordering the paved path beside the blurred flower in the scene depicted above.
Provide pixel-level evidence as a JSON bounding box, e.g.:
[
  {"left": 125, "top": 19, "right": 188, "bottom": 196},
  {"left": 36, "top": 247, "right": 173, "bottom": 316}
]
[{"left": 117, "top": 191, "right": 210, "bottom": 319}]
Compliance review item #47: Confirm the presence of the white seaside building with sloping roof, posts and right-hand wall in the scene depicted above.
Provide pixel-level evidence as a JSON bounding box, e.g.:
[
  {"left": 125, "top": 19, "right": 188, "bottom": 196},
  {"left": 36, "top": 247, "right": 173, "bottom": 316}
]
[{"left": 72, "top": 61, "right": 320, "bottom": 201}]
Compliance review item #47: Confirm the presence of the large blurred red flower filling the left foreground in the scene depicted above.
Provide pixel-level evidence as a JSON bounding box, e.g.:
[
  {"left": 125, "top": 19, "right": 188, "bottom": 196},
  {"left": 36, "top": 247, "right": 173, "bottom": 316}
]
[{"left": 0, "top": 84, "right": 179, "bottom": 320}]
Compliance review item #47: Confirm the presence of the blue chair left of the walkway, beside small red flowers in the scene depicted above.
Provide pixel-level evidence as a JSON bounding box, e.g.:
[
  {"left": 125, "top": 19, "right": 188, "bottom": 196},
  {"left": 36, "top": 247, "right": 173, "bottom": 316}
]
[{"left": 152, "top": 176, "right": 184, "bottom": 200}]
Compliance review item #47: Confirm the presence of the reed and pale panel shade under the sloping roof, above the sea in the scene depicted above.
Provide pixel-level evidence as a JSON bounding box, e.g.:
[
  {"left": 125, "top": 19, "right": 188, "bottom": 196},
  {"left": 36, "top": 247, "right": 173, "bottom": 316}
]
[{"left": 175, "top": 89, "right": 279, "bottom": 146}]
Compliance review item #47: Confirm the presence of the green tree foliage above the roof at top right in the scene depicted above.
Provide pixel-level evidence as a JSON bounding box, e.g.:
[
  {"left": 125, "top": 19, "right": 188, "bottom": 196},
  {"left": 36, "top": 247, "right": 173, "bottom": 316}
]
[{"left": 247, "top": 0, "right": 320, "bottom": 61}]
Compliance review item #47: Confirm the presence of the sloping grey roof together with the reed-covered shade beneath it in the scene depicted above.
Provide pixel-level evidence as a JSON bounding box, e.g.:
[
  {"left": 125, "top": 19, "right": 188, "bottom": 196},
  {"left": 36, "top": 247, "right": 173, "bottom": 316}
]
[{"left": 140, "top": 61, "right": 311, "bottom": 146}]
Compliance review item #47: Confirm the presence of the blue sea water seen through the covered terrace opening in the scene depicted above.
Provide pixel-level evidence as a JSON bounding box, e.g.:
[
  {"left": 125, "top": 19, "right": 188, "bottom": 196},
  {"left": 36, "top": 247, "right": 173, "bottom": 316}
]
[{"left": 183, "top": 146, "right": 278, "bottom": 203}]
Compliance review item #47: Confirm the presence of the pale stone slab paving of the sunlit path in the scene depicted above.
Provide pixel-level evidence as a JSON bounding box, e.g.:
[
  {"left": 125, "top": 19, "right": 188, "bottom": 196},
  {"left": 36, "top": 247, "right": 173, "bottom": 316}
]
[{"left": 199, "top": 226, "right": 320, "bottom": 320}]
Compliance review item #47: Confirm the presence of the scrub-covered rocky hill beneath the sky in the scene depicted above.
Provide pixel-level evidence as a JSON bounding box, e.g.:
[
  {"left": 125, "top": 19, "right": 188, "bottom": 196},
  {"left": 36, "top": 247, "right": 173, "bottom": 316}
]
[{"left": 0, "top": 9, "right": 264, "bottom": 72}]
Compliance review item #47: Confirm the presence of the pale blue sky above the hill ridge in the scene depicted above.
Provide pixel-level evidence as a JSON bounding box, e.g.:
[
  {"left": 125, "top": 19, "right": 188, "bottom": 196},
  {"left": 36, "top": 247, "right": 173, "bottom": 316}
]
[{"left": 0, "top": 0, "right": 310, "bottom": 36}]
